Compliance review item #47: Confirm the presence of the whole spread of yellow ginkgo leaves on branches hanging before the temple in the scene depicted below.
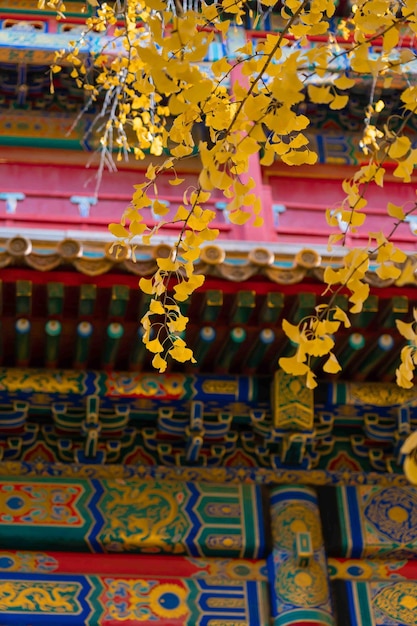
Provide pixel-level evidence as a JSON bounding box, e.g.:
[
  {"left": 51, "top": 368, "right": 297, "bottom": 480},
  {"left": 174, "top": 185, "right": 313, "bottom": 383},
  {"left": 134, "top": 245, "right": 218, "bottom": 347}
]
[{"left": 38, "top": 0, "right": 417, "bottom": 386}]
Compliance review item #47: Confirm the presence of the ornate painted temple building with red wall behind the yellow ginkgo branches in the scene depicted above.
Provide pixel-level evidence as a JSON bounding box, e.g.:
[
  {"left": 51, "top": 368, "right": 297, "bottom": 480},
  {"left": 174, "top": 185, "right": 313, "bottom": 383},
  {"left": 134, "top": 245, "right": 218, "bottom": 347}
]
[{"left": 0, "top": 0, "right": 417, "bottom": 626}]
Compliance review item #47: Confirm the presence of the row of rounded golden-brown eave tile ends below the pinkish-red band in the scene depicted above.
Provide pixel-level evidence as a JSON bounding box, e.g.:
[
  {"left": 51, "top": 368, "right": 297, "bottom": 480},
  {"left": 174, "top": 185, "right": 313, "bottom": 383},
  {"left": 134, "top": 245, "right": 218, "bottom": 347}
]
[{"left": 0, "top": 236, "right": 417, "bottom": 288}]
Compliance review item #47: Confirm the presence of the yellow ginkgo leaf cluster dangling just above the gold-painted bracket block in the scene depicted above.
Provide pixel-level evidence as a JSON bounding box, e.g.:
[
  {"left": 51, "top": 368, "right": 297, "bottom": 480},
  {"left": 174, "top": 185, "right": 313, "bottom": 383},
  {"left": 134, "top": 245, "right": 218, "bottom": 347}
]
[{"left": 279, "top": 304, "right": 350, "bottom": 389}]
